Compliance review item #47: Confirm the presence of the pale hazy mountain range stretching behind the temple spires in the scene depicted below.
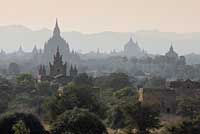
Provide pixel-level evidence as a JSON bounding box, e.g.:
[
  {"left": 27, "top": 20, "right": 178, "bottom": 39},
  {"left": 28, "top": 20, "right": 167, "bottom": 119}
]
[{"left": 0, "top": 25, "right": 200, "bottom": 63}]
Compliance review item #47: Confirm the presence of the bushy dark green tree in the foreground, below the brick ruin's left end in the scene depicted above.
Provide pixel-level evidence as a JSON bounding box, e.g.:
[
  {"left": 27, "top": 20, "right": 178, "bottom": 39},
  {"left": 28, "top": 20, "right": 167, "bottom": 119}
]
[{"left": 107, "top": 101, "right": 160, "bottom": 134}]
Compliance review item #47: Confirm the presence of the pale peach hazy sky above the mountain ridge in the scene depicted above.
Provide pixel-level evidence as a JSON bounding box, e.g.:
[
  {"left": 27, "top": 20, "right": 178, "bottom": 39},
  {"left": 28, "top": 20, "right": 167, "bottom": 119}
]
[{"left": 0, "top": 0, "right": 200, "bottom": 33}]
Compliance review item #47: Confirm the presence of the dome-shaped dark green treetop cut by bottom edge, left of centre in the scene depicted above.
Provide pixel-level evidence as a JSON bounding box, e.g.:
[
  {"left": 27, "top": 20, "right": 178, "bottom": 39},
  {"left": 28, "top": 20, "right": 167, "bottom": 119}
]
[{"left": 51, "top": 108, "right": 107, "bottom": 134}]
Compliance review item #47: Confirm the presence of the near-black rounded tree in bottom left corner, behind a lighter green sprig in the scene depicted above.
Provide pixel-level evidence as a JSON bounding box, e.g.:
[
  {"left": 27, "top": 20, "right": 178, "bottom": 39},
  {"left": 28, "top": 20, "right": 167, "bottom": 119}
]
[{"left": 0, "top": 113, "right": 45, "bottom": 134}]
